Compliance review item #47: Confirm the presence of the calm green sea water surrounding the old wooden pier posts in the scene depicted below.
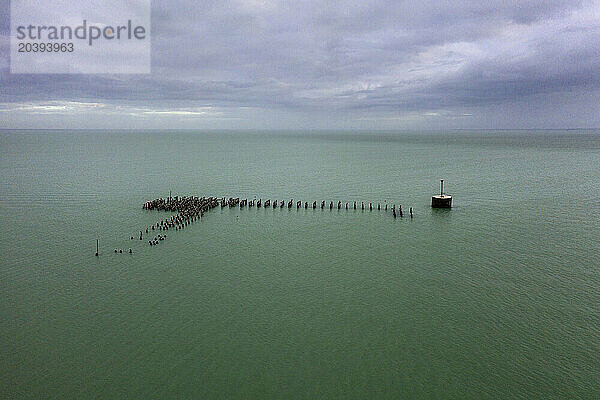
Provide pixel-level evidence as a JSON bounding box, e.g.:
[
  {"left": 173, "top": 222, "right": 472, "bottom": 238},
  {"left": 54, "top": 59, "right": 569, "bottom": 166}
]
[{"left": 0, "top": 131, "right": 600, "bottom": 399}]
